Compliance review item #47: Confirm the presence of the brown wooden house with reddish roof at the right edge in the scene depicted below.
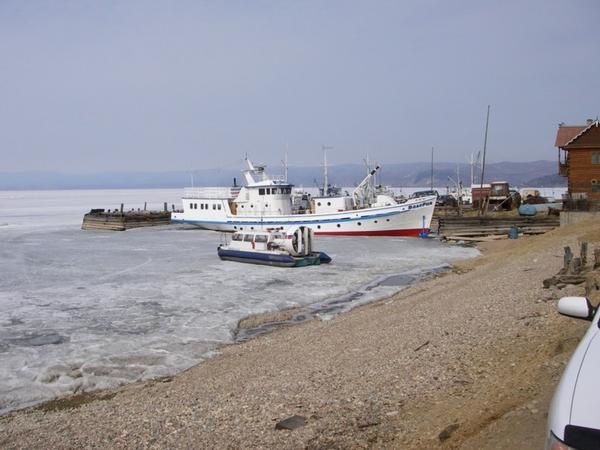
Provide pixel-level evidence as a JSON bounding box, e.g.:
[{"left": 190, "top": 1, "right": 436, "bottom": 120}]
[{"left": 555, "top": 119, "right": 600, "bottom": 209}]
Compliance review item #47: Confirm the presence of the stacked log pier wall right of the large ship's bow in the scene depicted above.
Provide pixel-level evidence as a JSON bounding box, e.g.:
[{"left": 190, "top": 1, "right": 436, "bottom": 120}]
[{"left": 437, "top": 216, "right": 560, "bottom": 240}]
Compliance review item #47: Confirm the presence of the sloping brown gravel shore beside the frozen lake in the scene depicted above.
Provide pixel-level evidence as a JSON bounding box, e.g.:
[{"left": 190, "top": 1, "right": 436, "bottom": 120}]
[{"left": 0, "top": 223, "right": 600, "bottom": 449}]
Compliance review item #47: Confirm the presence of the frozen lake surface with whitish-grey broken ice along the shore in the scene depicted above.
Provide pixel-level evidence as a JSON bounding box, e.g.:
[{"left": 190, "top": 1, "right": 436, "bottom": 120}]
[{"left": 0, "top": 189, "right": 477, "bottom": 413}]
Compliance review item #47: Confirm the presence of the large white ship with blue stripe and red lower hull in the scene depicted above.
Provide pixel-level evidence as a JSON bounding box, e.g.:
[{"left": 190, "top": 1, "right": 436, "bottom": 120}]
[{"left": 171, "top": 159, "right": 436, "bottom": 237}]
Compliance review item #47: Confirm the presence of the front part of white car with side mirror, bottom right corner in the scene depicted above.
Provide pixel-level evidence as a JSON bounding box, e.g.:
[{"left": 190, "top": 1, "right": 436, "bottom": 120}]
[{"left": 546, "top": 297, "right": 600, "bottom": 450}]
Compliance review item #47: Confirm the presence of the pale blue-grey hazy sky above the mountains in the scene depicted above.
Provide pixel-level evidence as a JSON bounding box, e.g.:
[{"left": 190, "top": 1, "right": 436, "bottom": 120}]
[{"left": 0, "top": 0, "right": 600, "bottom": 173}]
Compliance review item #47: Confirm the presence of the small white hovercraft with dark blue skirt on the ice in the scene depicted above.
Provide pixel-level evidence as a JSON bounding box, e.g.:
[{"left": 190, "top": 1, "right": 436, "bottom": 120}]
[{"left": 217, "top": 226, "right": 331, "bottom": 267}]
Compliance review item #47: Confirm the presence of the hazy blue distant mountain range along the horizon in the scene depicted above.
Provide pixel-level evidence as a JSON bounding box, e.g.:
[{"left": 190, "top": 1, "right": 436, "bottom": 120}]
[{"left": 0, "top": 161, "right": 567, "bottom": 190}]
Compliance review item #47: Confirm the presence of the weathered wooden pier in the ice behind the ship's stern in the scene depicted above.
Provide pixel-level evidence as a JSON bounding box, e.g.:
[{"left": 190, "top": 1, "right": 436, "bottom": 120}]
[{"left": 81, "top": 204, "right": 171, "bottom": 231}]
